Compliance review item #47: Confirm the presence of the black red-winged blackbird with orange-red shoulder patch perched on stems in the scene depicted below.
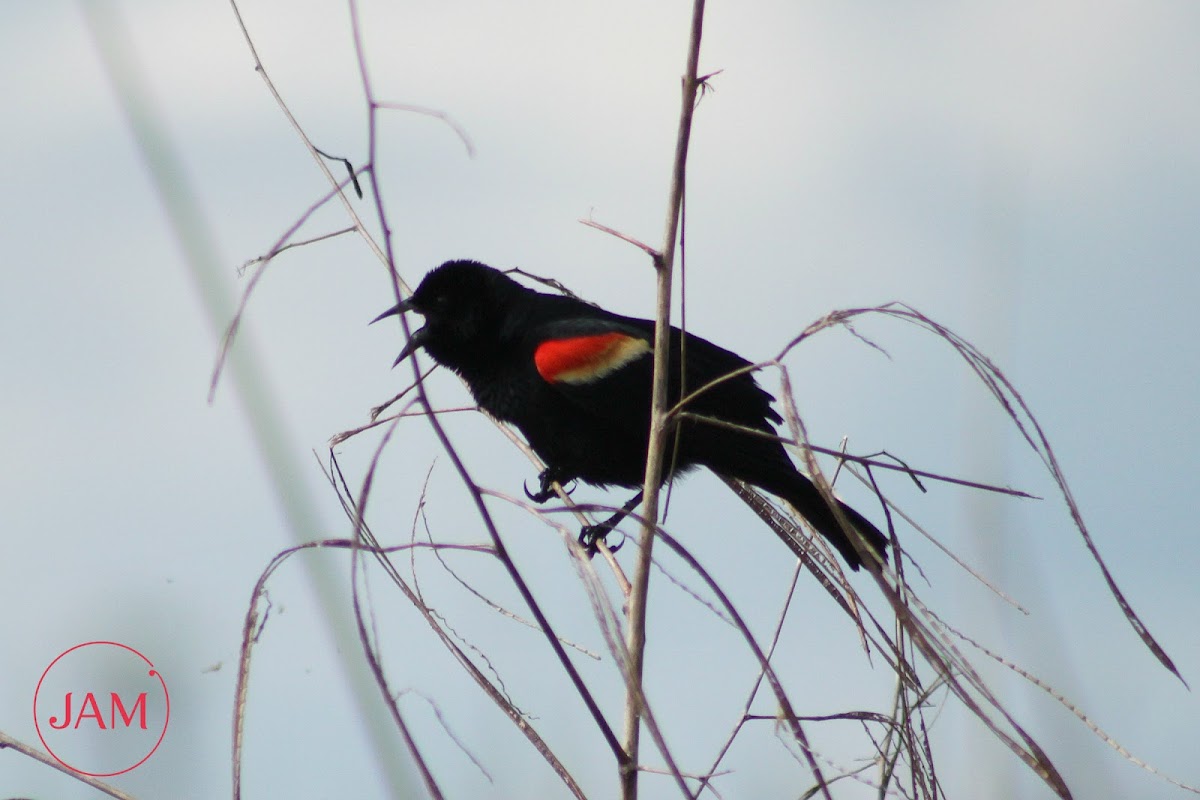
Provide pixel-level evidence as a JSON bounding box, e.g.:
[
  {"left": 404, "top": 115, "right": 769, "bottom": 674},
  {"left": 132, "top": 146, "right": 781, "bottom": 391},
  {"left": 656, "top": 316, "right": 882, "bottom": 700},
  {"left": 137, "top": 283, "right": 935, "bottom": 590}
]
[{"left": 377, "top": 261, "right": 888, "bottom": 570}]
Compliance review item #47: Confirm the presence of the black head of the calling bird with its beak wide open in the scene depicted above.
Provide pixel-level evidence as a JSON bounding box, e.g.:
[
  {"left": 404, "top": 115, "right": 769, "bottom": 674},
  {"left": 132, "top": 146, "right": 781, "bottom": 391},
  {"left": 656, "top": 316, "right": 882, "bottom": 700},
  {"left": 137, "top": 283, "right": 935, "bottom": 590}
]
[{"left": 372, "top": 261, "right": 528, "bottom": 371}]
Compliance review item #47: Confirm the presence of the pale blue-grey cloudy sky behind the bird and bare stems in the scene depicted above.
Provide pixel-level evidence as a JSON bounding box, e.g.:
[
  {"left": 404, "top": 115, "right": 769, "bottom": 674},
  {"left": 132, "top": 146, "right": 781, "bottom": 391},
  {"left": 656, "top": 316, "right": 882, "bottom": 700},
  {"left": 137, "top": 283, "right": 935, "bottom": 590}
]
[{"left": 0, "top": 0, "right": 1200, "bottom": 798}]
